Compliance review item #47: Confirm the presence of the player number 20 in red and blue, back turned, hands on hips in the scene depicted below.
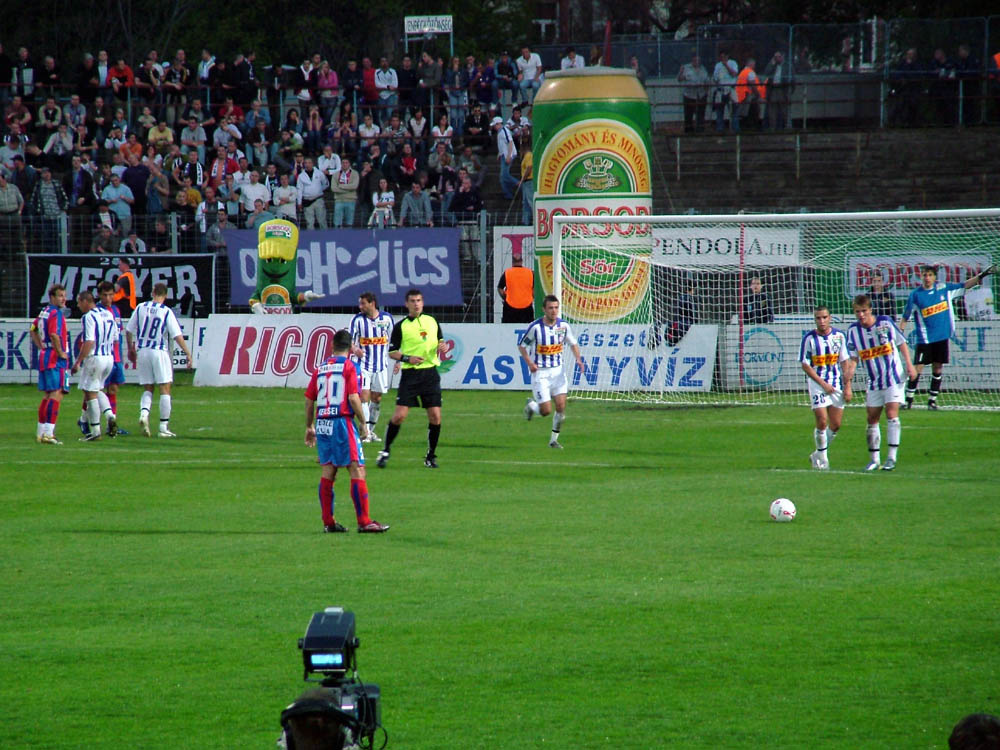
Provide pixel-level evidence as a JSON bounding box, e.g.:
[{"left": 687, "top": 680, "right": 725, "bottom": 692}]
[{"left": 306, "top": 331, "right": 389, "bottom": 534}]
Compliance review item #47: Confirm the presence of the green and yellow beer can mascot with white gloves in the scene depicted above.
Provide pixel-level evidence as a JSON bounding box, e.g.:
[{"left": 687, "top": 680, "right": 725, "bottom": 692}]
[{"left": 250, "top": 219, "right": 323, "bottom": 314}]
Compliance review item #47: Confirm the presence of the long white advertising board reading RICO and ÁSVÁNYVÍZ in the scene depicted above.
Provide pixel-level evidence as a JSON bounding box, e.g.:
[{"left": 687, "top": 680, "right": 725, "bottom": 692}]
[{"left": 194, "top": 314, "right": 718, "bottom": 391}]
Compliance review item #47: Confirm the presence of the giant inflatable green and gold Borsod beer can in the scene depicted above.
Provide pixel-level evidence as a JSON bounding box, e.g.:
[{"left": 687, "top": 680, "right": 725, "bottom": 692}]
[{"left": 531, "top": 67, "right": 652, "bottom": 322}]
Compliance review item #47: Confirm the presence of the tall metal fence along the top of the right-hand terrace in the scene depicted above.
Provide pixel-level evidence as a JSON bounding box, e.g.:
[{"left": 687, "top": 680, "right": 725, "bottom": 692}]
[{"left": 536, "top": 16, "right": 1000, "bottom": 127}]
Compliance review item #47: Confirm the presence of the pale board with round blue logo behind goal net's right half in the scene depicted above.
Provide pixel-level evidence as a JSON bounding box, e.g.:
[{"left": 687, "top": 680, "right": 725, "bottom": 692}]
[{"left": 722, "top": 317, "right": 1000, "bottom": 392}]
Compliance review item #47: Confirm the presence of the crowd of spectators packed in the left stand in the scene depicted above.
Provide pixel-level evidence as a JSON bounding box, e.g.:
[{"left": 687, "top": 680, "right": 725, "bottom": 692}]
[{"left": 0, "top": 46, "right": 556, "bottom": 252}]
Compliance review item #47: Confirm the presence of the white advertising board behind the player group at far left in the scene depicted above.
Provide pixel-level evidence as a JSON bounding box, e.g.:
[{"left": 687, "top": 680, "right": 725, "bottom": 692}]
[{"left": 0, "top": 317, "right": 208, "bottom": 383}]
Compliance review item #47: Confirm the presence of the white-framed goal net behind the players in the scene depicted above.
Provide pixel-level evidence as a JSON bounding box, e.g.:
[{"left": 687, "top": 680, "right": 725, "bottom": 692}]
[{"left": 552, "top": 210, "right": 1000, "bottom": 408}]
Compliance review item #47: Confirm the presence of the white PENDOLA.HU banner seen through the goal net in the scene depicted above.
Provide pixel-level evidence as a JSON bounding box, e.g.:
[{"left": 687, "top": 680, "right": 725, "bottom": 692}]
[{"left": 653, "top": 224, "right": 802, "bottom": 268}]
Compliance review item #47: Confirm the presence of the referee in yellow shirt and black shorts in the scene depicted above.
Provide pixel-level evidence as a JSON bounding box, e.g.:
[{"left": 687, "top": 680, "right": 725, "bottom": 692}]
[{"left": 375, "top": 289, "right": 446, "bottom": 469}]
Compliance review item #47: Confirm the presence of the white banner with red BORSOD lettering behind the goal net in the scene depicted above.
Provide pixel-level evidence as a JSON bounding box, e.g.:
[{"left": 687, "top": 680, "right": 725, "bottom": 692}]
[{"left": 845, "top": 253, "right": 993, "bottom": 299}]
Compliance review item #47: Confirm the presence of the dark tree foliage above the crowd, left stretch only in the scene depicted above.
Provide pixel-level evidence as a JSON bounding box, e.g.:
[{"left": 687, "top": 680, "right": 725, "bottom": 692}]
[{"left": 7, "top": 0, "right": 532, "bottom": 68}]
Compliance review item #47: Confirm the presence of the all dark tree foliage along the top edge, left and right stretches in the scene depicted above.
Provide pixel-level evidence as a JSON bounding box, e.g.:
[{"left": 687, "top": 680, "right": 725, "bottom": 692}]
[{"left": 0, "top": 0, "right": 998, "bottom": 69}]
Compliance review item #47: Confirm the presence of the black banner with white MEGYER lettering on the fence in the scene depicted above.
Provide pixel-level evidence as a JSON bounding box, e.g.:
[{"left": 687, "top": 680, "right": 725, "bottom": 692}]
[{"left": 25, "top": 253, "right": 215, "bottom": 315}]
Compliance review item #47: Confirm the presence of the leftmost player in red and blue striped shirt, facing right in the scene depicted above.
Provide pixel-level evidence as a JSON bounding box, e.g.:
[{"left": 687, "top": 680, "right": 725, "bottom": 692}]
[{"left": 30, "top": 284, "right": 69, "bottom": 445}]
